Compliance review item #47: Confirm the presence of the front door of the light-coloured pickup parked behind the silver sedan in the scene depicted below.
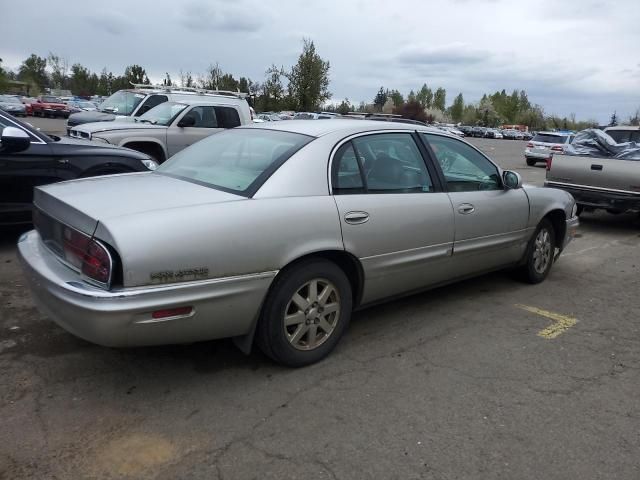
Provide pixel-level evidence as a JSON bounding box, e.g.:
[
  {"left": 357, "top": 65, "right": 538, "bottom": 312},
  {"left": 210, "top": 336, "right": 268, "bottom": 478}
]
[{"left": 167, "top": 105, "right": 222, "bottom": 156}]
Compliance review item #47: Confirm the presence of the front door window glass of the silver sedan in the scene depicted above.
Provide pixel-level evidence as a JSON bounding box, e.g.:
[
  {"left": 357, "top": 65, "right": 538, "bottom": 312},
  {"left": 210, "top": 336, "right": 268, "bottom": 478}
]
[{"left": 422, "top": 133, "right": 502, "bottom": 192}]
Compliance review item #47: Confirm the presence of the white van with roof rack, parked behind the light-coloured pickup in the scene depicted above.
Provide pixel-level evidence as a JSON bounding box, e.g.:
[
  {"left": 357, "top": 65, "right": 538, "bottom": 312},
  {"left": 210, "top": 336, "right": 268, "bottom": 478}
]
[{"left": 67, "top": 84, "right": 251, "bottom": 133}]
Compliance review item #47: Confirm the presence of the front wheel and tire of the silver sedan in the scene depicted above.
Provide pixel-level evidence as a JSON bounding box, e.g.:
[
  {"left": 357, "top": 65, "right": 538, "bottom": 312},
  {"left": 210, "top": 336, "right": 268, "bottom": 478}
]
[{"left": 518, "top": 218, "right": 556, "bottom": 284}]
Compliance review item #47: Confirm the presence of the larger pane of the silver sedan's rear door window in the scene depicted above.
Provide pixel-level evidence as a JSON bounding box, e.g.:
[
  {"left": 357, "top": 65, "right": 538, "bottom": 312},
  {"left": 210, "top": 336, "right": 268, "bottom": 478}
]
[{"left": 352, "top": 133, "right": 433, "bottom": 193}]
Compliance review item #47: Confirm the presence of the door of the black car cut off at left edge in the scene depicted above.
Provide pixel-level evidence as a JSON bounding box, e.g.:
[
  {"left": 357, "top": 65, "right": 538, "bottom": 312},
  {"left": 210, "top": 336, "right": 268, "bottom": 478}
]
[{"left": 0, "top": 116, "right": 58, "bottom": 222}]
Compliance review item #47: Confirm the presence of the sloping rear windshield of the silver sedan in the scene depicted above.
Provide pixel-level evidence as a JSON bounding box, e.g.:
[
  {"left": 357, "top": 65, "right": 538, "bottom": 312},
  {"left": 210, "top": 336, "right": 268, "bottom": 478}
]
[{"left": 156, "top": 128, "right": 312, "bottom": 197}]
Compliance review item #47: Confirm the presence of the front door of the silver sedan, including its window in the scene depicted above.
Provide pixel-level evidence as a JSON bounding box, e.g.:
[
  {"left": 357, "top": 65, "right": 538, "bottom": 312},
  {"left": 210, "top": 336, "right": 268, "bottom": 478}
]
[{"left": 422, "top": 133, "right": 531, "bottom": 275}]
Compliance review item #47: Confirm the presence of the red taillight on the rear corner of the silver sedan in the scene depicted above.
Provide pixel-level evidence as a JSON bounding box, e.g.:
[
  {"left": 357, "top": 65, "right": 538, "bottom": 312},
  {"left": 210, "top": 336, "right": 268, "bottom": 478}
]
[{"left": 63, "top": 227, "right": 113, "bottom": 287}]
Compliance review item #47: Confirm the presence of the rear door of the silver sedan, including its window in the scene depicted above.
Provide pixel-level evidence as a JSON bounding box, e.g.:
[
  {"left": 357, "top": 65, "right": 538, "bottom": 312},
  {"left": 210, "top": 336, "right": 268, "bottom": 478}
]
[{"left": 331, "top": 131, "right": 454, "bottom": 303}]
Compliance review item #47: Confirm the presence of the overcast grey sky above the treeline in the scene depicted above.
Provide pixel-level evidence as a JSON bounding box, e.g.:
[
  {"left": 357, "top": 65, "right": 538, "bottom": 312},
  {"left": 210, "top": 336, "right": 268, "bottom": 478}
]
[{"left": 0, "top": 0, "right": 640, "bottom": 123}]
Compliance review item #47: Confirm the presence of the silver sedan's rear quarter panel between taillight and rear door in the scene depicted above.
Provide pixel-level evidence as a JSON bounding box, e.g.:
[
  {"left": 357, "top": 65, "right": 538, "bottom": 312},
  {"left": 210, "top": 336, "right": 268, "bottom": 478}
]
[{"left": 95, "top": 195, "right": 343, "bottom": 287}]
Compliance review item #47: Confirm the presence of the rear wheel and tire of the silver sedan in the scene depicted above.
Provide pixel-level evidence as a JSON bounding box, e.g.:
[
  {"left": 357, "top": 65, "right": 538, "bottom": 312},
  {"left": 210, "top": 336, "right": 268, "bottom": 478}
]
[{"left": 256, "top": 259, "right": 352, "bottom": 367}]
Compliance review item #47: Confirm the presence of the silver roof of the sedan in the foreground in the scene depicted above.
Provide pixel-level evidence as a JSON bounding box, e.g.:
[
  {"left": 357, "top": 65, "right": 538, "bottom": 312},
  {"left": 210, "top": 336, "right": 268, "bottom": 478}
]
[{"left": 237, "top": 118, "right": 443, "bottom": 137}]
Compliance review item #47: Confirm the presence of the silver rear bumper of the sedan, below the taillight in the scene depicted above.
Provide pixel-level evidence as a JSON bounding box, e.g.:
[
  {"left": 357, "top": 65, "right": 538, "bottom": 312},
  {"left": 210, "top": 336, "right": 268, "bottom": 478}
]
[{"left": 18, "top": 230, "right": 277, "bottom": 347}]
